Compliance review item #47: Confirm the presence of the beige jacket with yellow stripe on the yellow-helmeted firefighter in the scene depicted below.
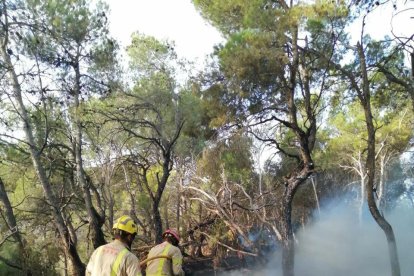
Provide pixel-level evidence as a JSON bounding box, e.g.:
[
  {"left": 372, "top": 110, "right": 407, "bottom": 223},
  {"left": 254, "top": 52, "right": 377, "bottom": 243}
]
[{"left": 86, "top": 240, "right": 142, "bottom": 276}]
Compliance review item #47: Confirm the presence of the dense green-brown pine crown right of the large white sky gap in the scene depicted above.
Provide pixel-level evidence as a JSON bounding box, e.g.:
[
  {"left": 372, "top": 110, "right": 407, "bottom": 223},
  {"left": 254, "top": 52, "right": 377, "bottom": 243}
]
[{"left": 193, "top": 0, "right": 348, "bottom": 132}]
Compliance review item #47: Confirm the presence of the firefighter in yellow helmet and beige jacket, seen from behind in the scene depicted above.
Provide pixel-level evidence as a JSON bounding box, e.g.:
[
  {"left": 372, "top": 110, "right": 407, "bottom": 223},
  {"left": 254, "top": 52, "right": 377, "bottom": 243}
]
[{"left": 86, "top": 216, "right": 142, "bottom": 276}]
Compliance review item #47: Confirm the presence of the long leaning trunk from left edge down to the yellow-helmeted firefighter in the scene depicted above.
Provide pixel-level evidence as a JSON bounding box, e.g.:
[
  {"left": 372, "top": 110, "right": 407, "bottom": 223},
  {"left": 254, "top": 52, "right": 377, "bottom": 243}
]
[{"left": 0, "top": 44, "right": 85, "bottom": 275}]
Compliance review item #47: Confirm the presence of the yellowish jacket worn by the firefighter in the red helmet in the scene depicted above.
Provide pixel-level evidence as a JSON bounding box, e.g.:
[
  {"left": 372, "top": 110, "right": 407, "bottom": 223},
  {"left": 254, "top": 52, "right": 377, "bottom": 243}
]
[{"left": 146, "top": 241, "right": 184, "bottom": 276}]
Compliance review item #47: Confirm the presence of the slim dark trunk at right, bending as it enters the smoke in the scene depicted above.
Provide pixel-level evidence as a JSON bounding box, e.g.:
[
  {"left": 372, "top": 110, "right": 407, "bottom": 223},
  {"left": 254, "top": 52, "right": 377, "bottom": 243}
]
[{"left": 357, "top": 43, "right": 401, "bottom": 276}]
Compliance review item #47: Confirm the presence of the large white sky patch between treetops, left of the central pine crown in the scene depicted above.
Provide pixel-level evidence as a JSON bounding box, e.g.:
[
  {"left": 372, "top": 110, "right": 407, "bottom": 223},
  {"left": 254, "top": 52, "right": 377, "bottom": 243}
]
[{"left": 106, "top": 0, "right": 223, "bottom": 63}]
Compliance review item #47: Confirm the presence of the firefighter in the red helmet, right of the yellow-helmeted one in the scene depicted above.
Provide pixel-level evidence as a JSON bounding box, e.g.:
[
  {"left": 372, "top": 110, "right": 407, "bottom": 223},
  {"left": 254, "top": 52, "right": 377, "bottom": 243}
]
[{"left": 146, "top": 229, "right": 184, "bottom": 276}]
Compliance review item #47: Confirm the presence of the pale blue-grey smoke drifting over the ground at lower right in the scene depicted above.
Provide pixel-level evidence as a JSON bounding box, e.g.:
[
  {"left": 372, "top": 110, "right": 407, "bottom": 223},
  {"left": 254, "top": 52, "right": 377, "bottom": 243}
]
[{"left": 220, "top": 197, "right": 414, "bottom": 276}]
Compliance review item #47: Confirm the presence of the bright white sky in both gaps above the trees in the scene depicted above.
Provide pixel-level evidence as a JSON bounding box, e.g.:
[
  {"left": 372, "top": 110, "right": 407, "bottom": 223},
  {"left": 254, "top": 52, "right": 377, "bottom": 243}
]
[{"left": 106, "top": 0, "right": 414, "bottom": 62}]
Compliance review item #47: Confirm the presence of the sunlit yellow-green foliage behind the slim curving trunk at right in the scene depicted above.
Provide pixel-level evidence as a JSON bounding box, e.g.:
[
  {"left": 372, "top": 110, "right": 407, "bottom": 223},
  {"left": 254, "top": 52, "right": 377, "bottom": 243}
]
[{"left": 316, "top": 96, "right": 413, "bottom": 174}]
